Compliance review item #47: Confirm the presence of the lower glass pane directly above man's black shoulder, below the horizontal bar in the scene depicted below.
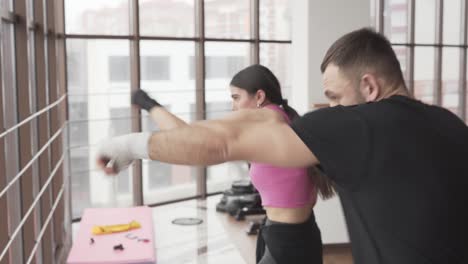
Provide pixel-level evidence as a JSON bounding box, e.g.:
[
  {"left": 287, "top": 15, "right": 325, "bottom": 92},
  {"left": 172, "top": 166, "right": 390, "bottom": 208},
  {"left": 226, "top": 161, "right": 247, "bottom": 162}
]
[{"left": 414, "top": 47, "right": 434, "bottom": 104}]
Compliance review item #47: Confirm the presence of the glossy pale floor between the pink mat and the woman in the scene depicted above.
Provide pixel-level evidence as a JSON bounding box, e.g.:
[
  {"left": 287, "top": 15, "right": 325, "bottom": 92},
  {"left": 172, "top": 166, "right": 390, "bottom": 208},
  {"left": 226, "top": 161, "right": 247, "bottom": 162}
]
[{"left": 73, "top": 195, "right": 353, "bottom": 264}]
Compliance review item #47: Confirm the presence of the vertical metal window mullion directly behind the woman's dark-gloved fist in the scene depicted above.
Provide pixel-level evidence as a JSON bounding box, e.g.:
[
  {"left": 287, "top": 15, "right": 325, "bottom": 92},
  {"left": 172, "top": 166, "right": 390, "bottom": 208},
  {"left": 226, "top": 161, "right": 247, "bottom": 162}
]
[{"left": 130, "top": 0, "right": 144, "bottom": 205}]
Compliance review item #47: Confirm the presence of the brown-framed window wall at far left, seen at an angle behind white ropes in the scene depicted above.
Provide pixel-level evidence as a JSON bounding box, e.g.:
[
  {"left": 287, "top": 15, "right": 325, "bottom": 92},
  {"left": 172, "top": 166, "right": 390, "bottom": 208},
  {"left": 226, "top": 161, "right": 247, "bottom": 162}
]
[{"left": 0, "top": 0, "right": 69, "bottom": 264}]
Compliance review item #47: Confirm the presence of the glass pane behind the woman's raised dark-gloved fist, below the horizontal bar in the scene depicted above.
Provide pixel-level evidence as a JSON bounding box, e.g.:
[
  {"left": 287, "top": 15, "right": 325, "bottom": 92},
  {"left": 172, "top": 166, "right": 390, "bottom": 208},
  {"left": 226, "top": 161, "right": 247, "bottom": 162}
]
[{"left": 140, "top": 40, "right": 196, "bottom": 204}]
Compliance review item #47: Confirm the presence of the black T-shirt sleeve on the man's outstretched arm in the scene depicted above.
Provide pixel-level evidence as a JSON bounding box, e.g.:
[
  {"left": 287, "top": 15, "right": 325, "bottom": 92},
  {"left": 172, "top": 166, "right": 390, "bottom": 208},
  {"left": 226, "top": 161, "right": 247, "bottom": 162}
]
[{"left": 291, "top": 106, "right": 372, "bottom": 187}]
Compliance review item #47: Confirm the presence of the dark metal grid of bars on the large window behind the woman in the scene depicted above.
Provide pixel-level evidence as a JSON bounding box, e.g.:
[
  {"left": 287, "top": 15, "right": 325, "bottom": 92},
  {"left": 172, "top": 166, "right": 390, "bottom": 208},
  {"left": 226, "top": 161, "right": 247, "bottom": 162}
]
[{"left": 65, "top": 0, "right": 291, "bottom": 216}]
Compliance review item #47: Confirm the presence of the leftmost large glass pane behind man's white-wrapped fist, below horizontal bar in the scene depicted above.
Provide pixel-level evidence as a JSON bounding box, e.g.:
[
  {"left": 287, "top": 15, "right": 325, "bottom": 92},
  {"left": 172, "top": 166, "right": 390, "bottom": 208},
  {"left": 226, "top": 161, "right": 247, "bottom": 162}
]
[{"left": 67, "top": 39, "right": 133, "bottom": 217}]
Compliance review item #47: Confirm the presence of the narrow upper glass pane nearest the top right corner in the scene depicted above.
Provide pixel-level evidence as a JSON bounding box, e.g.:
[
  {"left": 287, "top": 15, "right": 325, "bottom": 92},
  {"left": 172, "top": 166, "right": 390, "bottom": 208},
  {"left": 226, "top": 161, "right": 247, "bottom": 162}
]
[{"left": 443, "top": 0, "right": 462, "bottom": 44}]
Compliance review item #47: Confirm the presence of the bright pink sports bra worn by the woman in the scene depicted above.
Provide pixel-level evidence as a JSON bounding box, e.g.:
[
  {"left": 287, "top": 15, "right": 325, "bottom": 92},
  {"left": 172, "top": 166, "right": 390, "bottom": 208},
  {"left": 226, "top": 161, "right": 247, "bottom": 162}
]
[{"left": 250, "top": 104, "right": 317, "bottom": 208}]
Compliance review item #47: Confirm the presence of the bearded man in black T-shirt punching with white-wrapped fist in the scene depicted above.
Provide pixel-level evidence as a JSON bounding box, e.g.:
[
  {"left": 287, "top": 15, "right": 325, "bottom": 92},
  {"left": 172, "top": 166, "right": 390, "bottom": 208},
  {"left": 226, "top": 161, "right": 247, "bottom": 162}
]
[{"left": 98, "top": 29, "right": 468, "bottom": 264}]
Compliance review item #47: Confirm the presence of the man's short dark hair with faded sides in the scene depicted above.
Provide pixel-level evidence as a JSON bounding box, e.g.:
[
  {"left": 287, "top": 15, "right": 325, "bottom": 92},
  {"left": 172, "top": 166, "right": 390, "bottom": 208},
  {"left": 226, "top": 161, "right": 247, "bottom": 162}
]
[{"left": 320, "top": 28, "right": 406, "bottom": 88}]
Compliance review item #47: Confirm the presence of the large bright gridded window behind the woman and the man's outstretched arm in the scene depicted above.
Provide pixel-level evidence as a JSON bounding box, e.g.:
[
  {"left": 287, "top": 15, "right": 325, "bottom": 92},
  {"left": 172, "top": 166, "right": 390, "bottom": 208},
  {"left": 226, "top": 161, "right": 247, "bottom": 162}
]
[{"left": 65, "top": 0, "right": 291, "bottom": 217}]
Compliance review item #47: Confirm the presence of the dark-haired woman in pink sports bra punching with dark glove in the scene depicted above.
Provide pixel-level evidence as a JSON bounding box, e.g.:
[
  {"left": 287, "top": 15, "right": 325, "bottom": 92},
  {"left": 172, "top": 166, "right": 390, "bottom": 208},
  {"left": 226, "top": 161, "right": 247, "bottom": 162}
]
[{"left": 132, "top": 65, "right": 333, "bottom": 264}]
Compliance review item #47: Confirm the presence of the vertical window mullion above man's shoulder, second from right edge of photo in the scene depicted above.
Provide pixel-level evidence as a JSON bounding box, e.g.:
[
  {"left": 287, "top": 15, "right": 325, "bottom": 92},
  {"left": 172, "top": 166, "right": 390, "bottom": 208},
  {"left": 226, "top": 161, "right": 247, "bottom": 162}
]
[{"left": 433, "top": 0, "right": 444, "bottom": 105}]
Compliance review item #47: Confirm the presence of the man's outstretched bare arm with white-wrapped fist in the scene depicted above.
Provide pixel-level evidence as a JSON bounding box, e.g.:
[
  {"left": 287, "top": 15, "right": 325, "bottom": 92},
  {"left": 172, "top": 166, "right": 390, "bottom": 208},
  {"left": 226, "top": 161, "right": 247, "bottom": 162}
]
[{"left": 98, "top": 109, "right": 318, "bottom": 174}]
